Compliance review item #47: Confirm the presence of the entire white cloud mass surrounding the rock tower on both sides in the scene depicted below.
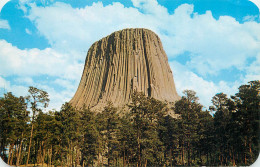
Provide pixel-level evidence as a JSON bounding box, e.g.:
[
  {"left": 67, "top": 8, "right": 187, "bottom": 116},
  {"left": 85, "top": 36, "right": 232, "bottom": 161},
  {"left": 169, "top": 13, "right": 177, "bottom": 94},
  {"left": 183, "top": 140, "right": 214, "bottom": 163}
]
[{"left": 0, "top": 0, "right": 260, "bottom": 109}]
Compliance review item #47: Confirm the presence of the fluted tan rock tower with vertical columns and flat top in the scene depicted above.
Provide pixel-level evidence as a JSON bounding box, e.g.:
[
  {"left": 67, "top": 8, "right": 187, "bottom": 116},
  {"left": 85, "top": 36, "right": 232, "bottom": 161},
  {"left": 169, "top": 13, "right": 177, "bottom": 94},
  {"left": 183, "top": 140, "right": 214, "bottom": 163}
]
[{"left": 70, "top": 29, "right": 179, "bottom": 109}]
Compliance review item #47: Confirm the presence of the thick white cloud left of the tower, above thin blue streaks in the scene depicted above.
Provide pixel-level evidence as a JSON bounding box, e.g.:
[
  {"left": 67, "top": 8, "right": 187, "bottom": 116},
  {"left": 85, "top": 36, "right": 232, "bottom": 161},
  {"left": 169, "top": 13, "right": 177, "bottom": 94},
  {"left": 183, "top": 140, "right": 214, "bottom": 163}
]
[{"left": 0, "top": 40, "right": 83, "bottom": 81}]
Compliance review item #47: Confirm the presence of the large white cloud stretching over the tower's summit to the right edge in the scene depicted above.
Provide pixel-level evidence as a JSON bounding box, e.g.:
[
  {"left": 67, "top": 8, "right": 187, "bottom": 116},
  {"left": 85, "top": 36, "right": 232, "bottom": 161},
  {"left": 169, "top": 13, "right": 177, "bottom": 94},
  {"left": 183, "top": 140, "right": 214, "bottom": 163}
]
[{"left": 24, "top": 0, "right": 260, "bottom": 75}]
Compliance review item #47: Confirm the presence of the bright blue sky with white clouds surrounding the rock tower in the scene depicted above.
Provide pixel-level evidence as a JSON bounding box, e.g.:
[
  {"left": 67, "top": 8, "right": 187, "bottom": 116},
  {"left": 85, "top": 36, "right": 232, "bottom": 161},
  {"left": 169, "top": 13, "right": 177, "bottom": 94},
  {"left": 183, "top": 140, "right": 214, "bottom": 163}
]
[{"left": 0, "top": 0, "right": 260, "bottom": 110}]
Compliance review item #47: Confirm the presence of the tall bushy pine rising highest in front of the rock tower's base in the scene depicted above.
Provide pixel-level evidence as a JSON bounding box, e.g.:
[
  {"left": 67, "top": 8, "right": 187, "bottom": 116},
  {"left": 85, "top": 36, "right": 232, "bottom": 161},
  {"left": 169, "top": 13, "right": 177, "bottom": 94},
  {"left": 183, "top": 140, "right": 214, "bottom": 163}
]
[{"left": 129, "top": 92, "right": 165, "bottom": 166}]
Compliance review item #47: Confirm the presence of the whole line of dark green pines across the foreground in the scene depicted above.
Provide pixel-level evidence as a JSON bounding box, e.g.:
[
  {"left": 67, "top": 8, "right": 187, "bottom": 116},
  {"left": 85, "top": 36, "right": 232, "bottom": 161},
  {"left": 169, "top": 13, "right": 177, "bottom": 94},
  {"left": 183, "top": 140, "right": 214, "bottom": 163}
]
[{"left": 0, "top": 81, "right": 260, "bottom": 167}]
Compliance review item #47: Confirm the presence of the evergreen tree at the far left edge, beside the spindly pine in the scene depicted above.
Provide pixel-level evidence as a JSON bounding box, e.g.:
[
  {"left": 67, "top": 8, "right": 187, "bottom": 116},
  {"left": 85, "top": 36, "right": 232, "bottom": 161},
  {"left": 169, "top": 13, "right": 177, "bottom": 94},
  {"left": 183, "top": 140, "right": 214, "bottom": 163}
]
[{"left": 0, "top": 92, "right": 29, "bottom": 165}]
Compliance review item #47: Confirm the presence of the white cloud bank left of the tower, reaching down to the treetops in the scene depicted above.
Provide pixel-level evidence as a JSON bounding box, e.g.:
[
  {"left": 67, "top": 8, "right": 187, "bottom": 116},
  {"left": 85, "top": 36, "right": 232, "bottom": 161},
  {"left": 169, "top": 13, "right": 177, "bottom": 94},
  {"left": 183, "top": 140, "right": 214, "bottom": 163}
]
[{"left": 0, "top": 40, "right": 80, "bottom": 110}]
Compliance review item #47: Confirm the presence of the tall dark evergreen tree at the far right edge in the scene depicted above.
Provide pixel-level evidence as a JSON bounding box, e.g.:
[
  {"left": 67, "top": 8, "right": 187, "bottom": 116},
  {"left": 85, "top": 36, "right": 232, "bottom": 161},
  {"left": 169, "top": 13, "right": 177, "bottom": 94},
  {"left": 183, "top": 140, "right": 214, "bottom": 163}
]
[{"left": 233, "top": 80, "right": 260, "bottom": 165}]
